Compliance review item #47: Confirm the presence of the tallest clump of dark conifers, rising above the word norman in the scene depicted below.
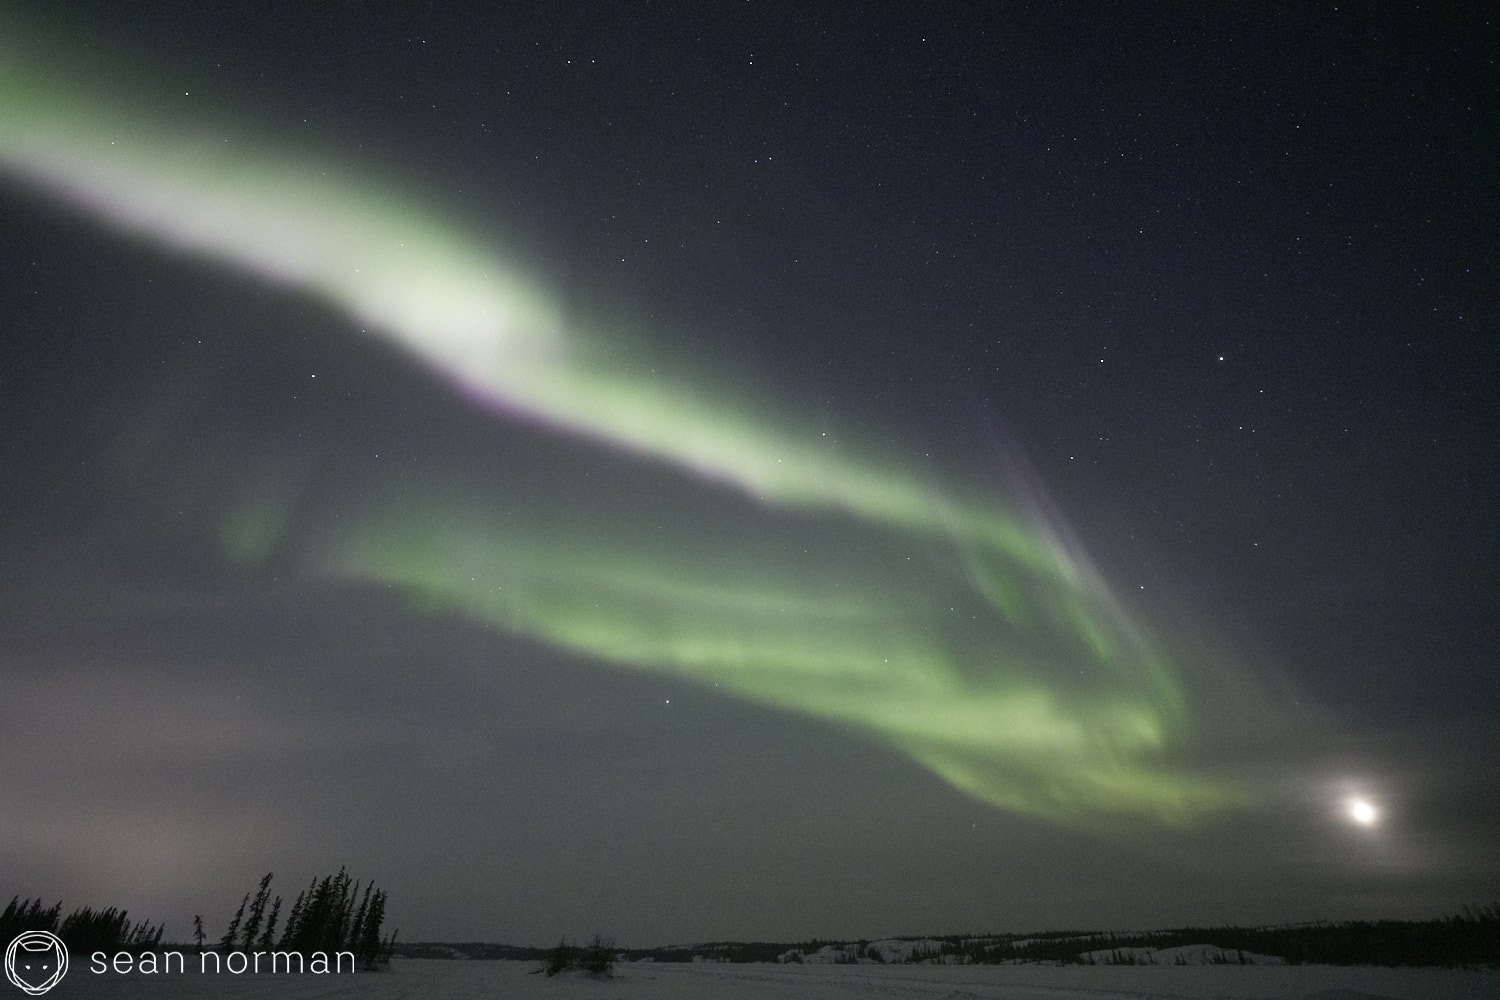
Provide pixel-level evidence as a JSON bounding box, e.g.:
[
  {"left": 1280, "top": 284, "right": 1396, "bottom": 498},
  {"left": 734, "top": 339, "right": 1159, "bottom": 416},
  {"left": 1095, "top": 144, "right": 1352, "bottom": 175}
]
[{"left": 214, "top": 868, "right": 396, "bottom": 969}]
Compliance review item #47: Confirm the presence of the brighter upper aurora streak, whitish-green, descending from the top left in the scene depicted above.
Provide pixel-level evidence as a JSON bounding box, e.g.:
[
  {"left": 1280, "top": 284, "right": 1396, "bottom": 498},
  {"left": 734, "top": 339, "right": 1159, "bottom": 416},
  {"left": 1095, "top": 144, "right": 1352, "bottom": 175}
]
[{"left": 0, "top": 27, "right": 1079, "bottom": 587}]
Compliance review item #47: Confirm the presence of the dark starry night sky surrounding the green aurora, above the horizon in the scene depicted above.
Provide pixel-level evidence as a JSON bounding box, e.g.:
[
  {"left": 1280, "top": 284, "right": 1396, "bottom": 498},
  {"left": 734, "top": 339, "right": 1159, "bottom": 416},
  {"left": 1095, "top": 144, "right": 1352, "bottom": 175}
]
[{"left": 0, "top": 3, "right": 1500, "bottom": 943}]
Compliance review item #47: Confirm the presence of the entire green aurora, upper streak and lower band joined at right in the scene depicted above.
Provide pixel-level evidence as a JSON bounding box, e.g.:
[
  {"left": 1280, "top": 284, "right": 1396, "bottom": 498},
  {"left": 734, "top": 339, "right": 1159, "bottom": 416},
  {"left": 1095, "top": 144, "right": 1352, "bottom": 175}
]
[{"left": 0, "top": 34, "right": 1272, "bottom": 831}]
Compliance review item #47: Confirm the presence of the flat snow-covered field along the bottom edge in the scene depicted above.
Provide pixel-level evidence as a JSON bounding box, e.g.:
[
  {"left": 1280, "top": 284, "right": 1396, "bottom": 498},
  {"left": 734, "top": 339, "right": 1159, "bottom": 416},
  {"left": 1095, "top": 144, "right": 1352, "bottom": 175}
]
[{"left": 46, "top": 960, "right": 1500, "bottom": 1000}]
